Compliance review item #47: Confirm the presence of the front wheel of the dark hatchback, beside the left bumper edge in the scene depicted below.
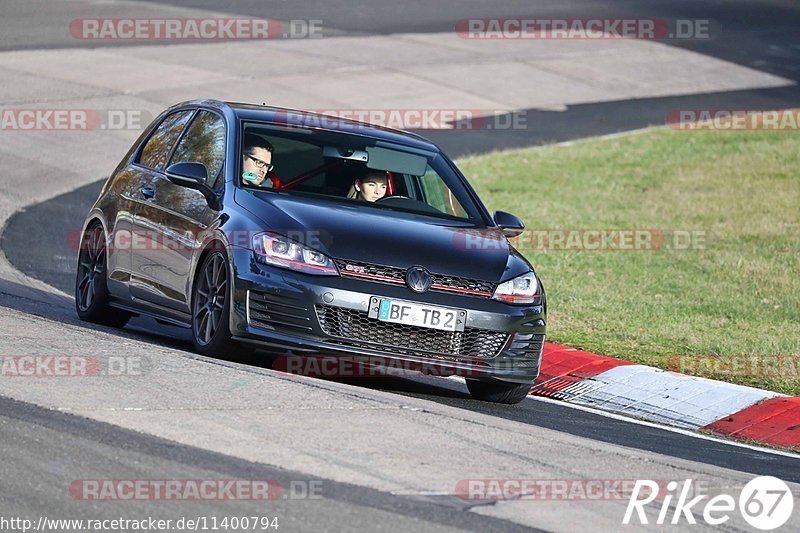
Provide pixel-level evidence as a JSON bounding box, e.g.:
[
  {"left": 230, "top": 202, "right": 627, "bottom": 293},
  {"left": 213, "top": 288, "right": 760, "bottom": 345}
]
[{"left": 192, "top": 251, "right": 246, "bottom": 361}]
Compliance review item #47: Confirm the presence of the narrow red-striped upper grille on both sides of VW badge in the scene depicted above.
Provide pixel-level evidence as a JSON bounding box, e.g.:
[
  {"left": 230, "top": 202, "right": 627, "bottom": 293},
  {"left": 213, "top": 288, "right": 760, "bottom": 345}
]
[{"left": 334, "top": 259, "right": 497, "bottom": 298}]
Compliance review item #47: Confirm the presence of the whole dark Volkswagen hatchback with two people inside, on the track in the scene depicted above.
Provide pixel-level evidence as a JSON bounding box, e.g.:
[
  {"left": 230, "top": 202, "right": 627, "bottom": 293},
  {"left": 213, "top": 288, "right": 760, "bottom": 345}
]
[{"left": 75, "top": 100, "right": 547, "bottom": 403}]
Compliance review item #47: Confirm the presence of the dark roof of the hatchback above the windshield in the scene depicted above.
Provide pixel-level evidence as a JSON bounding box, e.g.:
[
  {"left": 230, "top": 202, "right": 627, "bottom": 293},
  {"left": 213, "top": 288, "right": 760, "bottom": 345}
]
[{"left": 173, "top": 100, "right": 439, "bottom": 152}]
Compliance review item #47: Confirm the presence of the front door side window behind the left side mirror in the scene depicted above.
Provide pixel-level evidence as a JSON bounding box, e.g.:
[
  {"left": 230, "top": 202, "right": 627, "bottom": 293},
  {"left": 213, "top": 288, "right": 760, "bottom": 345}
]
[{"left": 170, "top": 111, "right": 225, "bottom": 188}]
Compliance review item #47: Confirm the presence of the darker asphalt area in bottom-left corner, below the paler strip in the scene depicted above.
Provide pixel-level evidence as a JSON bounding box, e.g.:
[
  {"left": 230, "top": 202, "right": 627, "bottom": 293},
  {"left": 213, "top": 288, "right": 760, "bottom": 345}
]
[{"left": 0, "top": 390, "right": 530, "bottom": 532}]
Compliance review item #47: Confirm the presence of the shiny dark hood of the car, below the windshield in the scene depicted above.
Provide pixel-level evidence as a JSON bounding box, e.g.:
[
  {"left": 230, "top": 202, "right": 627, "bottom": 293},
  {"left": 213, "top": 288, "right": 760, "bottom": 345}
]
[{"left": 235, "top": 189, "right": 531, "bottom": 282}]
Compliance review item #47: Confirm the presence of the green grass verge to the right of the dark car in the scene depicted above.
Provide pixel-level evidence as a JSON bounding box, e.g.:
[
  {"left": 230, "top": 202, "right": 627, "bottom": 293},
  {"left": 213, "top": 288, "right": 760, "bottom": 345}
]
[{"left": 459, "top": 128, "right": 800, "bottom": 394}]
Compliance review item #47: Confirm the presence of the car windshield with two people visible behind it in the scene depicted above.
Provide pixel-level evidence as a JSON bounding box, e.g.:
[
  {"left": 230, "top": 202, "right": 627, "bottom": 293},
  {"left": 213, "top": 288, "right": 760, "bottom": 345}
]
[{"left": 239, "top": 123, "right": 485, "bottom": 226}]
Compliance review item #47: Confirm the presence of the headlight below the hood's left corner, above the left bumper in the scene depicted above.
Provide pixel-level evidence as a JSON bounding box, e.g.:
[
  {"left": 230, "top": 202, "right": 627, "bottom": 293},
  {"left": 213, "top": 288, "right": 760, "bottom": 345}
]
[{"left": 253, "top": 231, "right": 339, "bottom": 276}]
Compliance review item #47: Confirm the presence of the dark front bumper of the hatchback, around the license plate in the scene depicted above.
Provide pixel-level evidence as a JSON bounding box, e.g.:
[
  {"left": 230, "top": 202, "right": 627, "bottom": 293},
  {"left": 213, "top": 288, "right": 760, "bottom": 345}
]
[{"left": 230, "top": 250, "right": 546, "bottom": 383}]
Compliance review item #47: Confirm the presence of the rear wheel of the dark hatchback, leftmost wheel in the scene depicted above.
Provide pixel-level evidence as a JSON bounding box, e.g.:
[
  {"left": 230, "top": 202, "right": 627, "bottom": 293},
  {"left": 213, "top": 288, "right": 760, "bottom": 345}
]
[{"left": 75, "top": 222, "right": 131, "bottom": 328}]
